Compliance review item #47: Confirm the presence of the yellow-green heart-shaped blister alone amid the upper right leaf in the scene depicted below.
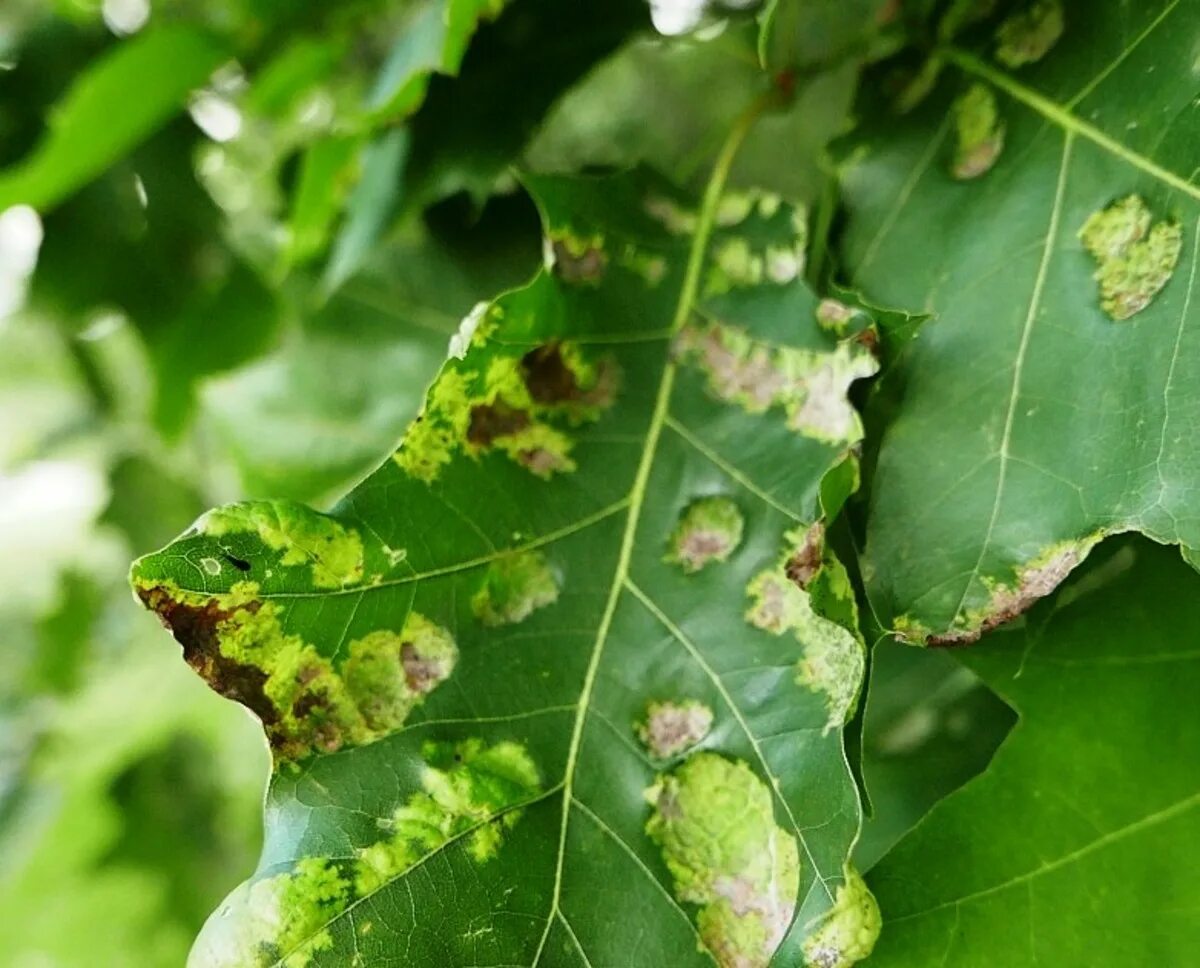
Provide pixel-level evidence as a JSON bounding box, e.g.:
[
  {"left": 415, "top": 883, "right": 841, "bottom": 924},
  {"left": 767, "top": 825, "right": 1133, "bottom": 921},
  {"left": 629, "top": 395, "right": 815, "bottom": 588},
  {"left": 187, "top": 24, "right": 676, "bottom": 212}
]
[{"left": 1079, "top": 194, "right": 1183, "bottom": 320}]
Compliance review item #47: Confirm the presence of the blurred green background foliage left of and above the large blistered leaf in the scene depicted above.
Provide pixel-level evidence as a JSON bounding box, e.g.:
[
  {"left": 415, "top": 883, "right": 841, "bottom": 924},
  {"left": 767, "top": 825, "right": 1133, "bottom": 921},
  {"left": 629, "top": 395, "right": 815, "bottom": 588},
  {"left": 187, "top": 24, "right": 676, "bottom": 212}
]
[{"left": 0, "top": 0, "right": 1010, "bottom": 968}]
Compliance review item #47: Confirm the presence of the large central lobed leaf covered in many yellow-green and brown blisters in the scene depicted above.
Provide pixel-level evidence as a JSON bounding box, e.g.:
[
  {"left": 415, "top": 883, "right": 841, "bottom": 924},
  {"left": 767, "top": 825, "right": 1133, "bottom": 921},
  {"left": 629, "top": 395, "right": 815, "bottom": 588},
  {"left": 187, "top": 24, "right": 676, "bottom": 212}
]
[{"left": 133, "top": 147, "right": 877, "bottom": 966}]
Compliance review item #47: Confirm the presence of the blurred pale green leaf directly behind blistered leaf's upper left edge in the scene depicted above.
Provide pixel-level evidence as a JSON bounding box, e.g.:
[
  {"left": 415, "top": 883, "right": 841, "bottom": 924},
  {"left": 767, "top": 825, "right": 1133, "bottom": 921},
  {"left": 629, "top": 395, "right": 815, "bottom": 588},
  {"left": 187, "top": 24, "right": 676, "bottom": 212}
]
[{"left": 210, "top": 215, "right": 539, "bottom": 506}]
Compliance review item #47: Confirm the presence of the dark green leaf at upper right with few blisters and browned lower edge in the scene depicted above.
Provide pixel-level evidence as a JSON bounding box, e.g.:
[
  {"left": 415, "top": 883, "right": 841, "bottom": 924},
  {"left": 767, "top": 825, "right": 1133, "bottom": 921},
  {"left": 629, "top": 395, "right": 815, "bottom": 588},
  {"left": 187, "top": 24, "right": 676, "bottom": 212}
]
[{"left": 844, "top": 2, "right": 1200, "bottom": 642}]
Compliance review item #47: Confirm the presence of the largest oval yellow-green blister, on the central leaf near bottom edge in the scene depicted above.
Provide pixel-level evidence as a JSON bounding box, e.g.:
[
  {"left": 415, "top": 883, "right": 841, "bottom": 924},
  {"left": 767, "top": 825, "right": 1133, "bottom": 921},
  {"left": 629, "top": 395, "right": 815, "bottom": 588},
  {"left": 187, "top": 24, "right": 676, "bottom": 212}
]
[{"left": 646, "top": 752, "right": 800, "bottom": 968}]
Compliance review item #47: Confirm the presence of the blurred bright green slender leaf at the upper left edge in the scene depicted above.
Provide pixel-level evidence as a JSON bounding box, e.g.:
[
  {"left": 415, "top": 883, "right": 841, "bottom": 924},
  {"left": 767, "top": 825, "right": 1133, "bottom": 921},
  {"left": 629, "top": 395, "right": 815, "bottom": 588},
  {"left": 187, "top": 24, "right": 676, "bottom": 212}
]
[{"left": 0, "top": 26, "right": 228, "bottom": 211}]
